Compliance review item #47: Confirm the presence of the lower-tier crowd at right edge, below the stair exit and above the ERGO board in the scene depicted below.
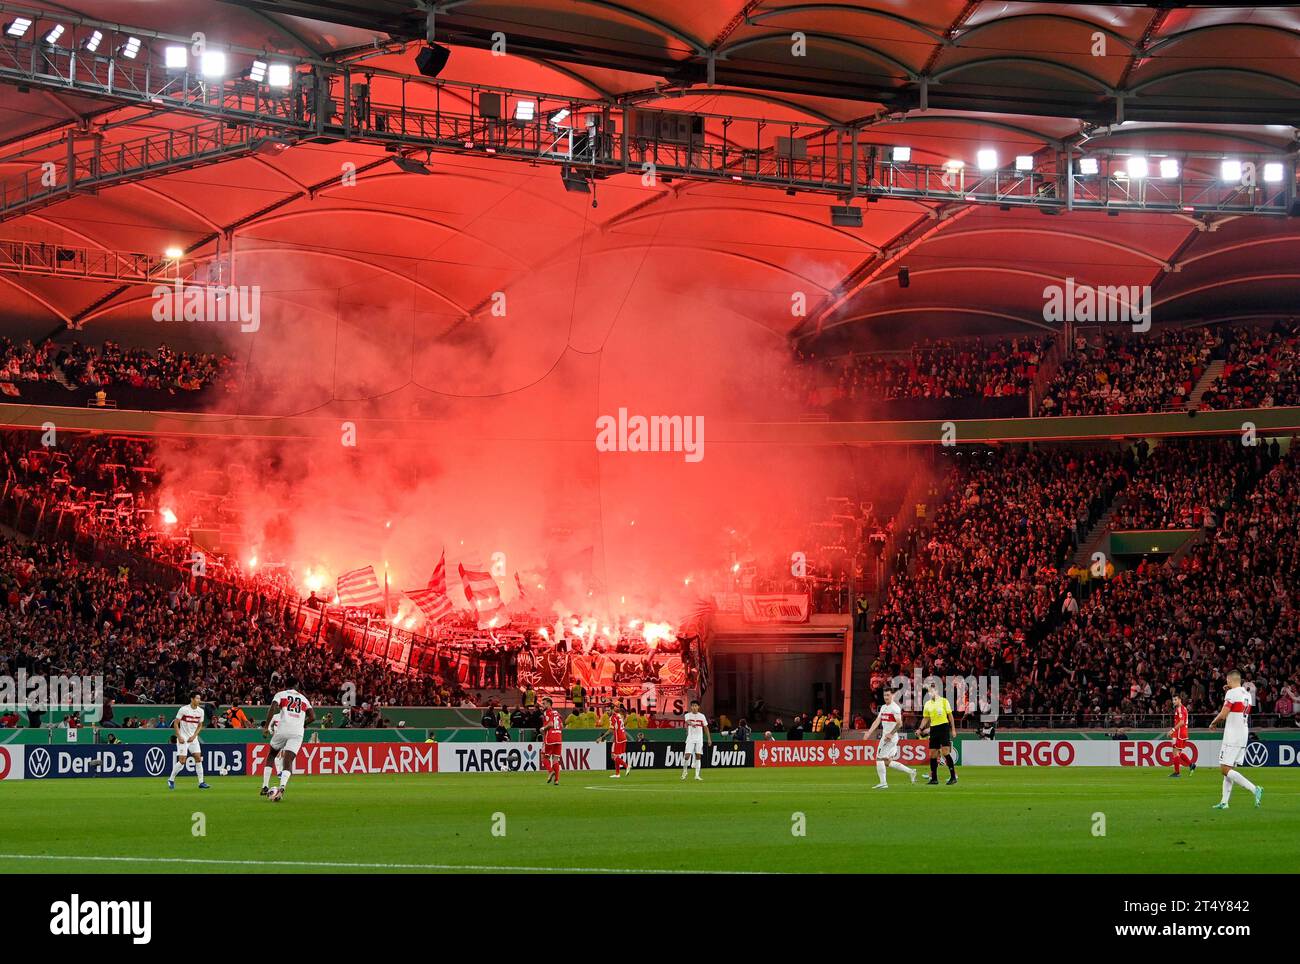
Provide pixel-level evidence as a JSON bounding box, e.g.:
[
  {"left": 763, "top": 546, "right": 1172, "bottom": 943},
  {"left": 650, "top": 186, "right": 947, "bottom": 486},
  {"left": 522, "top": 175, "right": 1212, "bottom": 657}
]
[{"left": 1009, "top": 451, "right": 1300, "bottom": 726}]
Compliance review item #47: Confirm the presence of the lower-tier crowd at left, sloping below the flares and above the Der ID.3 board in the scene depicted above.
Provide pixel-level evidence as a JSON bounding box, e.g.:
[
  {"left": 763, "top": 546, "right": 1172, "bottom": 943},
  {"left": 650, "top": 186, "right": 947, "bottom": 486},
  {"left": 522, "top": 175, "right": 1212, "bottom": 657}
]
[{"left": 0, "top": 538, "right": 458, "bottom": 705}]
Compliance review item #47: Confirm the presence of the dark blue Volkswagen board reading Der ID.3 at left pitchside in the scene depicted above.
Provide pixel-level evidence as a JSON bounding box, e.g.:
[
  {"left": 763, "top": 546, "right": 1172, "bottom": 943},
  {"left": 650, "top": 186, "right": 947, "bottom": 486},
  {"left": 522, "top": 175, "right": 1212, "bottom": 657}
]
[{"left": 22, "top": 743, "right": 248, "bottom": 780}]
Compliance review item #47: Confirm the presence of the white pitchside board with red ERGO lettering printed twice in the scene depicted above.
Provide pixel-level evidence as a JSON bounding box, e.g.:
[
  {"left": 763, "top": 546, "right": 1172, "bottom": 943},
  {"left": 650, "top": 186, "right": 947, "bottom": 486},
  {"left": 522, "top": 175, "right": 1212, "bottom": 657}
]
[{"left": 961, "top": 738, "right": 1242, "bottom": 769}]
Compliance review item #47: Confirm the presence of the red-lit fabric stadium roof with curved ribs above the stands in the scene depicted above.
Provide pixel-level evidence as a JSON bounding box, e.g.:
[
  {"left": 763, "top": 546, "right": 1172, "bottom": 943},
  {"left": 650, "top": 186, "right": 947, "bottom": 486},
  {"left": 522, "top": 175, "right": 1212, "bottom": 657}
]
[{"left": 0, "top": 0, "right": 1300, "bottom": 355}]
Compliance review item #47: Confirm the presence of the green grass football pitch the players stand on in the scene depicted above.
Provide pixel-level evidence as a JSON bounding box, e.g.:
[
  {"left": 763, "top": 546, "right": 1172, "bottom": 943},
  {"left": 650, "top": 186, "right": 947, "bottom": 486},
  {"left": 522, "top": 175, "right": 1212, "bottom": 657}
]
[{"left": 0, "top": 767, "right": 1300, "bottom": 873}]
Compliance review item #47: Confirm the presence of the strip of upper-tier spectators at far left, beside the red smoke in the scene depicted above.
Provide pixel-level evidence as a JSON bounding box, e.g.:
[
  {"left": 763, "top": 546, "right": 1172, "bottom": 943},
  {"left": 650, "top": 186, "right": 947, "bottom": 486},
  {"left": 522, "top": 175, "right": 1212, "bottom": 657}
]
[{"left": 0, "top": 338, "right": 235, "bottom": 395}]
